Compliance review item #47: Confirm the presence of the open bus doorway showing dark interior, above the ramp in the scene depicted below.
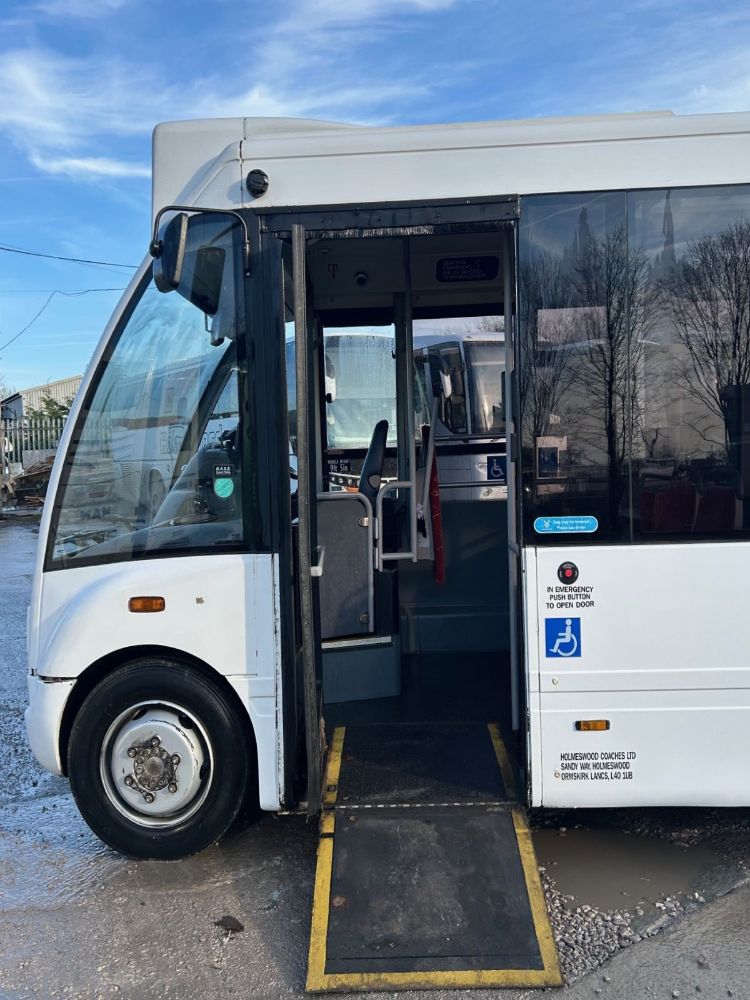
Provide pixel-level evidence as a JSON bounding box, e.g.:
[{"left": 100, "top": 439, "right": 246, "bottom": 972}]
[{"left": 287, "top": 220, "right": 519, "bottom": 730}]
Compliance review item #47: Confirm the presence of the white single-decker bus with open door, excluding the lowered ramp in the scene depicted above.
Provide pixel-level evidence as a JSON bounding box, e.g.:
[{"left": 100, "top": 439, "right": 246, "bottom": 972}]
[{"left": 22, "top": 107, "right": 750, "bottom": 987}]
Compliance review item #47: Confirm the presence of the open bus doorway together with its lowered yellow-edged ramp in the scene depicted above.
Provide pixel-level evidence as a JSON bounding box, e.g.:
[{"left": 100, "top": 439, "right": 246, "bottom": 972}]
[{"left": 276, "top": 206, "right": 559, "bottom": 990}]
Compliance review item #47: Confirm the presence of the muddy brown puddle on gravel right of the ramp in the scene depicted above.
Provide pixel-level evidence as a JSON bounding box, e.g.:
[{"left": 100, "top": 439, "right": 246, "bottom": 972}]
[{"left": 533, "top": 827, "right": 720, "bottom": 915}]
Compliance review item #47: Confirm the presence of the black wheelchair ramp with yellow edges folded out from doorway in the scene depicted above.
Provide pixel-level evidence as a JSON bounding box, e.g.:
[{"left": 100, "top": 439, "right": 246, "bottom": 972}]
[{"left": 307, "top": 724, "right": 561, "bottom": 992}]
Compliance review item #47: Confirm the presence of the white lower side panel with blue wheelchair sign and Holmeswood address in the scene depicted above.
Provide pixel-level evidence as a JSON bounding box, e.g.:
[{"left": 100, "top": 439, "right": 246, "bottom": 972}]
[{"left": 524, "top": 542, "right": 750, "bottom": 807}]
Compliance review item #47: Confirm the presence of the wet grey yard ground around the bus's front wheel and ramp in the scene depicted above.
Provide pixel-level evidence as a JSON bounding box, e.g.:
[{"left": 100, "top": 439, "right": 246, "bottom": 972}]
[{"left": 0, "top": 520, "right": 750, "bottom": 1000}]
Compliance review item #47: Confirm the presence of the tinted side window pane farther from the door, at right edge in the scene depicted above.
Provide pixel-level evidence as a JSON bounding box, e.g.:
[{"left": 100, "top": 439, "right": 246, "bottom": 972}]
[{"left": 628, "top": 187, "right": 750, "bottom": 540}]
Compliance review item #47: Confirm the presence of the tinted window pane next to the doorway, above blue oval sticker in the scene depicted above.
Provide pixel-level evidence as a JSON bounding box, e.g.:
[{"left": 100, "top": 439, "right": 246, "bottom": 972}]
[{"left": 519, "top": 192, "right": 632, "bottom": 541}]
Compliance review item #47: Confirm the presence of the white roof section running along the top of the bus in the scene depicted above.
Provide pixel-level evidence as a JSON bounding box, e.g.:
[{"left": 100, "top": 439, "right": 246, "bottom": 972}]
[{"left": 153, "top": 112, "right": 750, "bottom": 220}]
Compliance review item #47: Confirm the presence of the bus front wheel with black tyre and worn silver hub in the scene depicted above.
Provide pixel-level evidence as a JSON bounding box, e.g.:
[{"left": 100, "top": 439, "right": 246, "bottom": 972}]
[{"left": 68, "top": 658, "right": 250, "bottom": 859}]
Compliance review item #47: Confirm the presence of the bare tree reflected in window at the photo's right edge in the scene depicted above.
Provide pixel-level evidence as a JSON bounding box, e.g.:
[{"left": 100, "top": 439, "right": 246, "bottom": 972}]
[{"left": 663, "top": 221, "right": 750, "bottom": 457}]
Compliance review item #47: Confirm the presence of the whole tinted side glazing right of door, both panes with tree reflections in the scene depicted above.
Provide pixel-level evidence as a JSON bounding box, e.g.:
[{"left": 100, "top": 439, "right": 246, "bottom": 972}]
[{"left": 519, "top": 187, "right": 750, "bottom": 541}]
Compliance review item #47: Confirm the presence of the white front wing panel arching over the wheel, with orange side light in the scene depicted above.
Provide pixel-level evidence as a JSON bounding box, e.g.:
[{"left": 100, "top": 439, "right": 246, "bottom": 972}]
[{"left": 27, "top": 554, "right": 283, "bottom": 809}]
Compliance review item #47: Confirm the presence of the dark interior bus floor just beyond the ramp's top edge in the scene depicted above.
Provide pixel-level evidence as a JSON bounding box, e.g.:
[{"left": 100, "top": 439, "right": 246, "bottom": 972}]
[{"left": 325, "top": 650, "right": 510, "bottom": 733}]
